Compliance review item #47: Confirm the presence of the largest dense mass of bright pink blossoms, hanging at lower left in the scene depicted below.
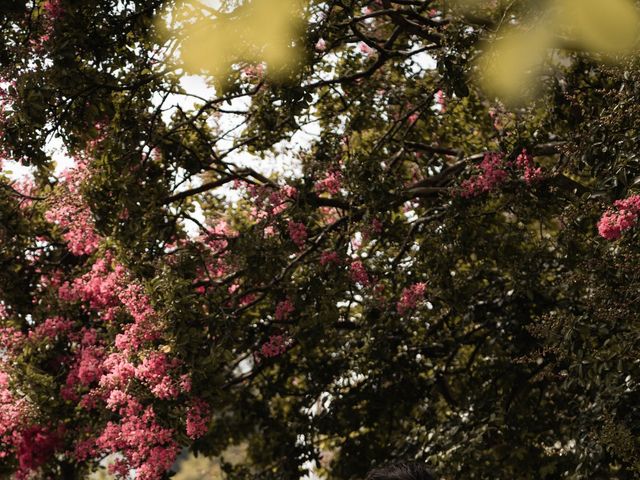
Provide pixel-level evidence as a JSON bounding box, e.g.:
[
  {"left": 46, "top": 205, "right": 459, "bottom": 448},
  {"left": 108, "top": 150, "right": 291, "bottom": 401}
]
[{"left": 46, "top": 256, "right": 198, "bottom": 480}]
